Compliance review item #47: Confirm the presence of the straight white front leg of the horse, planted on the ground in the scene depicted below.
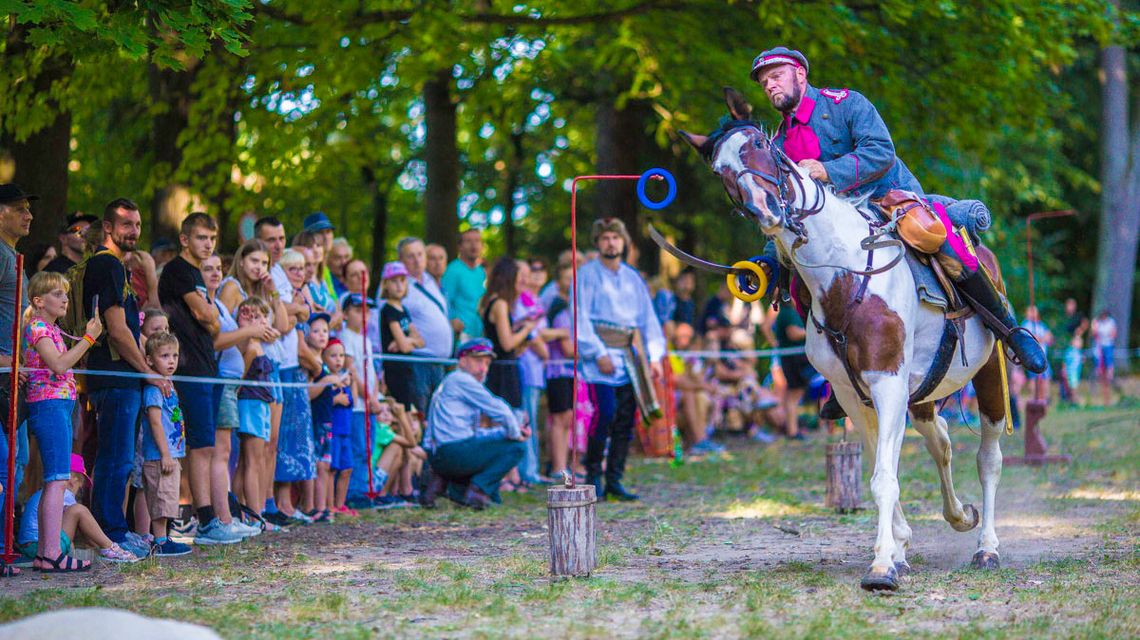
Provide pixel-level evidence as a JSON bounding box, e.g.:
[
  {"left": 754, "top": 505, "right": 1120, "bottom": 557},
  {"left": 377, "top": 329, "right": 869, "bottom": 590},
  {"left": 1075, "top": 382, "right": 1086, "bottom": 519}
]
[{"left": 860, "top": 370, "right": 906, "bottom": 591}]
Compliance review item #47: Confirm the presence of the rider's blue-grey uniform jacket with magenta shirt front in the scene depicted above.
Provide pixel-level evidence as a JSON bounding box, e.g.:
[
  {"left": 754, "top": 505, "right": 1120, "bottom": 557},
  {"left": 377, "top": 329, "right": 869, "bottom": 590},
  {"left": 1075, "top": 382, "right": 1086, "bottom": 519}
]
[{"left": 774, "top": 84, "right": 923, "bottom": 199}]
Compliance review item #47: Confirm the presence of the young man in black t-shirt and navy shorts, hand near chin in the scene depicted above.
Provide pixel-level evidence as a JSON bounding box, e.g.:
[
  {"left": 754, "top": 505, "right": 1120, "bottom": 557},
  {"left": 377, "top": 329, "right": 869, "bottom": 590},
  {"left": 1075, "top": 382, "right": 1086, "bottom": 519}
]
[{"left": 158, "top": 212, "right": 243, "bottom": 544}]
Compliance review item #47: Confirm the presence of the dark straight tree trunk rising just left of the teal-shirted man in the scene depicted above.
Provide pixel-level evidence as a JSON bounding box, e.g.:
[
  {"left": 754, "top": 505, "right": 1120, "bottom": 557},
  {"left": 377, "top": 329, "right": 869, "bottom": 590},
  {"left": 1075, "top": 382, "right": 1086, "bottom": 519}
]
[{"left": 424, "top": 67, "right": 459, "bottom": 251}]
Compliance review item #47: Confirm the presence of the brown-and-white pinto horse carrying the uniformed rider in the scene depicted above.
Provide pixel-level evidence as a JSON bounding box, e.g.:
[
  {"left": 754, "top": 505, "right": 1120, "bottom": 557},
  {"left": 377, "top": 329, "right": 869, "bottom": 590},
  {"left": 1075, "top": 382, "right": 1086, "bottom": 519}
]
[{"left": 682, "top": 89, "right": 1007, "bottom": 591}]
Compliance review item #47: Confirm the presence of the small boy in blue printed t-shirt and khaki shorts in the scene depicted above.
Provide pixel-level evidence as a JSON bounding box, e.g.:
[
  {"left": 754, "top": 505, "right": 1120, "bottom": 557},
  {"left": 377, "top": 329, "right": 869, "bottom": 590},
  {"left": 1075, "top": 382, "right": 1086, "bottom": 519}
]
[{"left": 143, "top": 333, "right": 190, "bottom": 556}]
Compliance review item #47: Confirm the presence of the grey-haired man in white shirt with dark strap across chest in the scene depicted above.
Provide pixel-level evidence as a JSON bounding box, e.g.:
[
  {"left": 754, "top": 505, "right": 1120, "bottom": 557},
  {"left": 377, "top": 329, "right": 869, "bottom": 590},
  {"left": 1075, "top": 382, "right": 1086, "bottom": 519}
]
[{"left": 396, "top": 237, "right": 455, "bottom": 414}]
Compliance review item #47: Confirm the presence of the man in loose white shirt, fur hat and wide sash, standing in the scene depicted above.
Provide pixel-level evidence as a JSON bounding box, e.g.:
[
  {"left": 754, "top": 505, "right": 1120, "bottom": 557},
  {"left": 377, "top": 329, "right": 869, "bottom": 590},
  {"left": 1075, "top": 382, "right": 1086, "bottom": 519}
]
[{"left": 577, "top": 218, "right": 665, "bottom": 501}]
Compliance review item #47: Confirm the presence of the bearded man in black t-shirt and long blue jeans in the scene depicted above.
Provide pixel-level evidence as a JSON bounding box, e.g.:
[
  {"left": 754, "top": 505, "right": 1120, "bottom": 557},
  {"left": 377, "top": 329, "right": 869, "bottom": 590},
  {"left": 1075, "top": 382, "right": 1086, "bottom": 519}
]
[{"left": 83, "top": 197, "right": 171, "bottom": 557}]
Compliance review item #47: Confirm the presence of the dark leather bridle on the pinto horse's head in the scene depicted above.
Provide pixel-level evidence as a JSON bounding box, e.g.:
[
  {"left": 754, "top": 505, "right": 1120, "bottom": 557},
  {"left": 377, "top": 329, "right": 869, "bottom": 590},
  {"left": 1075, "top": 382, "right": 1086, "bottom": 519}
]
[{"left": 711, "top": 123, "right": 827, "bottom": 237}]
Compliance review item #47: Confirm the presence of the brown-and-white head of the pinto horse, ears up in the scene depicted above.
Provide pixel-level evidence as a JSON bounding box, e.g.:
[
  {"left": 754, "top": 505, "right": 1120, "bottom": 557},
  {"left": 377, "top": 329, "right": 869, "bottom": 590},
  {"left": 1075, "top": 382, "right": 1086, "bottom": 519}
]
[{"left": 681, "top": 88, "right": 800, "bottom": 234}]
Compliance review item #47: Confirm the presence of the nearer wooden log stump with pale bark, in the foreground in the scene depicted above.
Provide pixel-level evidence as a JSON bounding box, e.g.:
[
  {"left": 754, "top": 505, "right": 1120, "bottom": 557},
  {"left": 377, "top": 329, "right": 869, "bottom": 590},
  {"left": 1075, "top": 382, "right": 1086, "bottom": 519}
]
[{"left": 546, "top": 485, "right": 597, "bottom": 576}]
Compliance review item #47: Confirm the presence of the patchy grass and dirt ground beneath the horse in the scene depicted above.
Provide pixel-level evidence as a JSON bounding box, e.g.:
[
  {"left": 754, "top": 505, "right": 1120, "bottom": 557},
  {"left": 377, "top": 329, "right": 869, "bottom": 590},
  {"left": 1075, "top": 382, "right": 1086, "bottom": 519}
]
[{"left": 0, "top": 381, "right": 1140, "bottom": 640}]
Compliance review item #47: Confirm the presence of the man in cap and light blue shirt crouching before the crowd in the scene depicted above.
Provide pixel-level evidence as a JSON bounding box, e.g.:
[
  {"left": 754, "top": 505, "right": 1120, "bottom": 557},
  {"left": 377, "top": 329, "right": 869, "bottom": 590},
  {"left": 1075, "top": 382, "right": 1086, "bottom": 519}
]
[{"left": 423, "top": 338, "right": 530, "bottom": 509}]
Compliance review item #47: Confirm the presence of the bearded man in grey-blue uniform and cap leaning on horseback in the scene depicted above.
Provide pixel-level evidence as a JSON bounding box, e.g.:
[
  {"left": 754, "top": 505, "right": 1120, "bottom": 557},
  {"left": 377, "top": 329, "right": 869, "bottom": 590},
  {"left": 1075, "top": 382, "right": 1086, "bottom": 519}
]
[{"left": 751, "top": 47, "right": 1045, "bottom": 419}]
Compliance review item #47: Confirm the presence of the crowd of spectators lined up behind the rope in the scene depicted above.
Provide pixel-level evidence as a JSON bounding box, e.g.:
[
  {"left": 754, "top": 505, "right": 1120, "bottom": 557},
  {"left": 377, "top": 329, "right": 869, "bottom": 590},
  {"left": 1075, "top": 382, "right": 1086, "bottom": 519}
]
[{"left": 0, "top": 185, "right": 1116, "bottom": 573}]
